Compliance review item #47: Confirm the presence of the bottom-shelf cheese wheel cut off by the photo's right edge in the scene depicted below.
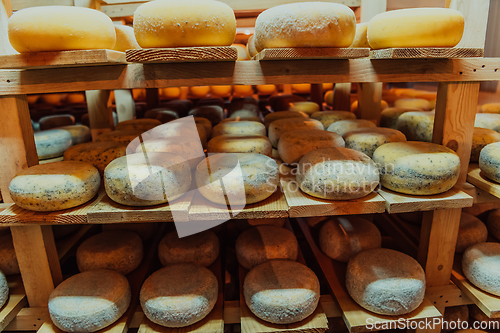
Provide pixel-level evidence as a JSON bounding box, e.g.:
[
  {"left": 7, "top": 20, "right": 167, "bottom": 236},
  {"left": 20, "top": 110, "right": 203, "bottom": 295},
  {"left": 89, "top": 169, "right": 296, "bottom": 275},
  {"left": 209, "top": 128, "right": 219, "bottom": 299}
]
[{"left": 462, "top": 242, "right": 500, "bottom": 296}]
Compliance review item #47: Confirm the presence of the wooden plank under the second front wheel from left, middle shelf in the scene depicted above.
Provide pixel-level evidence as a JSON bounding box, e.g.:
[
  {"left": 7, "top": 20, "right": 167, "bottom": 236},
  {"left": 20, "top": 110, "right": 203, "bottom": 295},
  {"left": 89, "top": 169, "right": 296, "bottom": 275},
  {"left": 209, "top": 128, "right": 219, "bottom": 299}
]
[{"left": 88, "top": 191, "right": 193, "bottom": 224}]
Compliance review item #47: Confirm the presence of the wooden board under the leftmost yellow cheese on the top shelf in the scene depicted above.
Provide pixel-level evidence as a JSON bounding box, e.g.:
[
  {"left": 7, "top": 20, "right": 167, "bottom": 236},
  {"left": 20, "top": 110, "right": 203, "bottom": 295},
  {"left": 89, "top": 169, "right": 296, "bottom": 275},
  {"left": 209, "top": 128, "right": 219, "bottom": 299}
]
[{"left": 0, "top": 49, "right": 126, "bottom": 69}]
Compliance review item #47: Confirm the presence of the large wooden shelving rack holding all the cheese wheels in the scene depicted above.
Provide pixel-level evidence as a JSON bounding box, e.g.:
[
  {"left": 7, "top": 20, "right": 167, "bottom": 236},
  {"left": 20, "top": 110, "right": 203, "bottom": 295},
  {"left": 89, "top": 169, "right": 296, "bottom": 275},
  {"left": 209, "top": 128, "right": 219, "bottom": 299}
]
[{"left": 0, "top": 0, "right": 500, "bottom": 333}]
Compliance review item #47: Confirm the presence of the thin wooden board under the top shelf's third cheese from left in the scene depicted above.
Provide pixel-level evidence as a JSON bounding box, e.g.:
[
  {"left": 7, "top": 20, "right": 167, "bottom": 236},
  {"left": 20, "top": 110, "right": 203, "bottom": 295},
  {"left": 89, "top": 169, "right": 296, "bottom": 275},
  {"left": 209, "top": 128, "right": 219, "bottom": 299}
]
[{"left": 252, "top": 47, "right": 370, "bottom": 60}]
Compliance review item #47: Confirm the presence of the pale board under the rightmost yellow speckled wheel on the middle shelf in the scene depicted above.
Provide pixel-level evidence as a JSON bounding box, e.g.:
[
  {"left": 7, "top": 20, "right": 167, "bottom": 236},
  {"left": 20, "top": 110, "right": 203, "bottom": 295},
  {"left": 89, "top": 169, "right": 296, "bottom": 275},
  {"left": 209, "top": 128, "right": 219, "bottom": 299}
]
[{"left": 378, "top": 188, "right": 474, "bottom": 214}]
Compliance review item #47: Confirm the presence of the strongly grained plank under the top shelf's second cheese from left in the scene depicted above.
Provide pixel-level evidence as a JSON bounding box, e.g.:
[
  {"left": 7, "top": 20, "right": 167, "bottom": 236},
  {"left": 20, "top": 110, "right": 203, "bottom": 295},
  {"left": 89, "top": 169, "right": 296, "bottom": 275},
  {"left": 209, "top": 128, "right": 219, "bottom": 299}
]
[{"left": 126, "top": 46, "right": 238, "bottom": 63}]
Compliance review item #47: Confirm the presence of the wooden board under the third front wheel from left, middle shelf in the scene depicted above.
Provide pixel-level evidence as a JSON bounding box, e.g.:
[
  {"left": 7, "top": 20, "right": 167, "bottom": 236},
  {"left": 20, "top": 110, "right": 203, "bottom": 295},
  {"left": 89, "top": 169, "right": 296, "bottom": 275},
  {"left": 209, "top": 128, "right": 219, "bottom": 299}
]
[{"left": 189, "top": 189, "right": 288, "bottom": 221}]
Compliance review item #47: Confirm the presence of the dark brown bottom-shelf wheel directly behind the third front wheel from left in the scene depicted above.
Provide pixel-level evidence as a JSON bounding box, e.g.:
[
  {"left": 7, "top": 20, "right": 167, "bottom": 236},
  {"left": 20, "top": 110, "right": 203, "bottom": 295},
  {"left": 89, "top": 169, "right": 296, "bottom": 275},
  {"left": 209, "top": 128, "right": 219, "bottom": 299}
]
[{"left": 235, "top": 225, "right": 299, "bottom": 269}]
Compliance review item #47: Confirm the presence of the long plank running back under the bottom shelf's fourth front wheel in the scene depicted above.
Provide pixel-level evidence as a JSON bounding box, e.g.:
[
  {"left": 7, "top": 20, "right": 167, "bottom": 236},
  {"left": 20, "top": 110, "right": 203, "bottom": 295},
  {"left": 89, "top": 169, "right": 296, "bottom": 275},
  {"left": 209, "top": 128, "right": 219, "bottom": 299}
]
[{"left": 297, "top": 219, "right": 442, "bottom": 333}]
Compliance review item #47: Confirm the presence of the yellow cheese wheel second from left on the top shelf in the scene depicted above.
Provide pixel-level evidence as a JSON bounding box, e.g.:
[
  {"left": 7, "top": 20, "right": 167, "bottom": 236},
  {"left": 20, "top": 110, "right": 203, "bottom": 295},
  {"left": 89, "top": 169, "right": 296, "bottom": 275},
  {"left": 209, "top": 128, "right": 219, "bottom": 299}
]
[{"left": 134, "top": 0, "right": 236, "bottom": 48}]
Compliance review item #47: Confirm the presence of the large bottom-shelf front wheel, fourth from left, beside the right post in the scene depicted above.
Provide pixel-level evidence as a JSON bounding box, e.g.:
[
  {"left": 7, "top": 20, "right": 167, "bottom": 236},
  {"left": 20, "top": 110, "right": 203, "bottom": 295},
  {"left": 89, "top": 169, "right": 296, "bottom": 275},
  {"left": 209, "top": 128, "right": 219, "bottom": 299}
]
[{"left": 345, "top": 249, "right": 425, "bottom": 316}]
